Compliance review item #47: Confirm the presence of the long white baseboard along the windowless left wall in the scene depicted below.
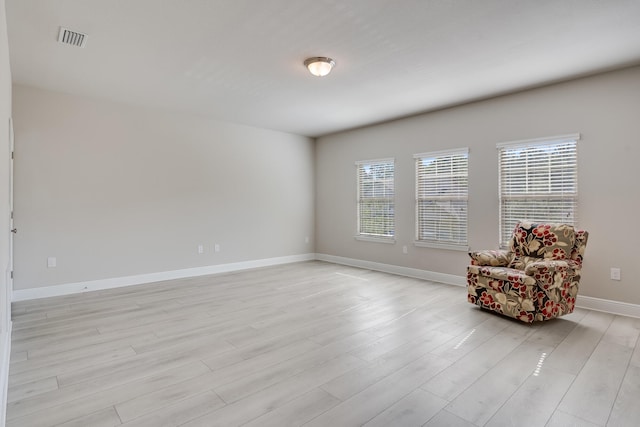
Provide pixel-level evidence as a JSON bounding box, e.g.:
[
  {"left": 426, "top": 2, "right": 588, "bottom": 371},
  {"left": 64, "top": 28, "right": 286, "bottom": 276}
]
[{"left": 11, "top": 253, "right": 315, "bottom": 302}]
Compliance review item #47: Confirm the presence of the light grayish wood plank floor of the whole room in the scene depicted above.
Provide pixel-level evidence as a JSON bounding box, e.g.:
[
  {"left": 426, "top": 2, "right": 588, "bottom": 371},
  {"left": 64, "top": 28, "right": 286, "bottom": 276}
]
[{"left": 7, "top": 262, "right": 640, "bottom": 427}]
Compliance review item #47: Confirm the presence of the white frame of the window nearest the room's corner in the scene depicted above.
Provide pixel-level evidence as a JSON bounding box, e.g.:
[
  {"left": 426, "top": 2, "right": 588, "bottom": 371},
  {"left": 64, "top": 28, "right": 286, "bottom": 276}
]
[{"left": 355, "top": 157, "right": 396, "bottom": 243}]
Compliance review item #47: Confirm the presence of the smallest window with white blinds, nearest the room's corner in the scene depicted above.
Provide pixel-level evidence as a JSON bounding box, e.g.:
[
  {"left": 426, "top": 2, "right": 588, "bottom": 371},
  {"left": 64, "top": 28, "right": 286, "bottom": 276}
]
[{"left": 356, "top": 159, "right": 395, "bottom": 241}]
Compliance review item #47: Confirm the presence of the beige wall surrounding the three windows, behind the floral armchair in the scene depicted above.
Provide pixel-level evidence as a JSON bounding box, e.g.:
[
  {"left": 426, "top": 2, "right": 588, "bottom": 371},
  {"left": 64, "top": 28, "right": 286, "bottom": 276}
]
[{"left": 316, "top": 67, "right": 640, "bottom": 304}]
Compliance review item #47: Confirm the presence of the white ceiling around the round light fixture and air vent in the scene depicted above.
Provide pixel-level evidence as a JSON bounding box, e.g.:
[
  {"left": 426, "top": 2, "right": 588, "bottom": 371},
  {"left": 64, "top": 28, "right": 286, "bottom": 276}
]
[{"left": 6, "top": 0, "right": 640, "bottom": 136}]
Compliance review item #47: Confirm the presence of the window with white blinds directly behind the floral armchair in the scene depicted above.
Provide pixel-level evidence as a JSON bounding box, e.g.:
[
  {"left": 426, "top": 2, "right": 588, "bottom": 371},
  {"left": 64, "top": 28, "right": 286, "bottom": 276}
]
[{"left": 497, "top": 134, "right": 580, "bottom": 246}]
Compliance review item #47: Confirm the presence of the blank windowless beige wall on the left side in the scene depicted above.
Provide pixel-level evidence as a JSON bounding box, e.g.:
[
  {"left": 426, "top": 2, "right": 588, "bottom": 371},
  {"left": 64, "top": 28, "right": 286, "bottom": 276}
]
[{"left": 13, "top": 85, "right": 314, "bottom": 289}]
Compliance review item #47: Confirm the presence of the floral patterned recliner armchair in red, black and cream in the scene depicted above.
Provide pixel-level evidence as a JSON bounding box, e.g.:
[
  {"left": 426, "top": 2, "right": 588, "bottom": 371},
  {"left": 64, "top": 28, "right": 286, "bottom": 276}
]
[{"left": 467, "top": 221, "right": 589, "bottom": 323}]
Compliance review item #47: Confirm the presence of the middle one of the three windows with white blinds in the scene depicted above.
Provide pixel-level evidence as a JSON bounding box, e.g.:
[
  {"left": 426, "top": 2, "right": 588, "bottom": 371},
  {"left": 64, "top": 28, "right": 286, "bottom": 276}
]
[{"left": 414, "top": 148, "right": 469, "bottom": 250}]
